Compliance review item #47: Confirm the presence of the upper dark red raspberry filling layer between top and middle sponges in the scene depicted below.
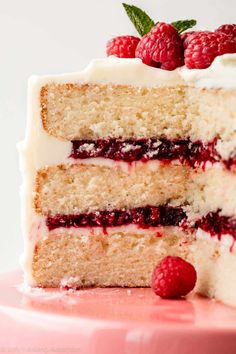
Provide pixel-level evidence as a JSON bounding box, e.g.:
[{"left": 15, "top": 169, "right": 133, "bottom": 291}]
[{"left": 70, "top": 138, "right": 236, "bottom": 169}]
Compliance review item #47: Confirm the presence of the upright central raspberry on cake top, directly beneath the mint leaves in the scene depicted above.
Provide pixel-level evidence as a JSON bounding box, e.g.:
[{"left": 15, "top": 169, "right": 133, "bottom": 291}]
[{"left": 135, "top": 22, "right": 184, "bottom": 70}]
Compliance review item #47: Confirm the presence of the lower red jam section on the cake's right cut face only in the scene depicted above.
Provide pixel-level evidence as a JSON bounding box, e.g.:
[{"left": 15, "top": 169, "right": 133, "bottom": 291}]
[{"left": 195, "top": 210, "right": 236, "bottom": 239}]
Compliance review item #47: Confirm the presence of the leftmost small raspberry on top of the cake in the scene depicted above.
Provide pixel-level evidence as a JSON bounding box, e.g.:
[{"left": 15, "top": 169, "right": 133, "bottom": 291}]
[{"left": 107, "top": 36, "right": 140, "bottom": 58}]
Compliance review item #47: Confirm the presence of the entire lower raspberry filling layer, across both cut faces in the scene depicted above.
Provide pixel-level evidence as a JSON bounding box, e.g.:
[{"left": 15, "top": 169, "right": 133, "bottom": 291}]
[{"left": 46, "top": 205, "right": 236, "bottom": 239}]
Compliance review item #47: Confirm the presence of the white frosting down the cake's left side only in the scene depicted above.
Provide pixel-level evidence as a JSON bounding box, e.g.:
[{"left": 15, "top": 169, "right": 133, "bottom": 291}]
[{"left": 18, "top": 76, "right": 72, "bottom": 283}]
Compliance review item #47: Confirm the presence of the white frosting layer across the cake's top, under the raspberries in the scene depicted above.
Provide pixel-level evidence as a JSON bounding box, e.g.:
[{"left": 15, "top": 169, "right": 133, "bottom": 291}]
[{"left": 30, "top": 54, "right": 236, "bottom": 88}]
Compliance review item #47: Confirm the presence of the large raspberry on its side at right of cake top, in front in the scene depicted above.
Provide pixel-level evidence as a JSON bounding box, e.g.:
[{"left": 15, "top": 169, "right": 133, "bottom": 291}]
[{"left": 184, "top": 32, "right": 236, "bottom": 69}]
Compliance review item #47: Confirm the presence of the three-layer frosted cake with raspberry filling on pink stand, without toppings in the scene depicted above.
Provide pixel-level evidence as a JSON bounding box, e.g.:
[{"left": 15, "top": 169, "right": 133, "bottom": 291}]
[{"left": 21, "top": 6, "right": 236, "bottom": 305}]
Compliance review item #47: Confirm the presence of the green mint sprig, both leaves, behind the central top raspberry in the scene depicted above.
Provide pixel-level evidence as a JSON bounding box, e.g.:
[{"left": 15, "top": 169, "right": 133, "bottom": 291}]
[{"left": 122, "top": 3, "right": 197, "bottom": 37}]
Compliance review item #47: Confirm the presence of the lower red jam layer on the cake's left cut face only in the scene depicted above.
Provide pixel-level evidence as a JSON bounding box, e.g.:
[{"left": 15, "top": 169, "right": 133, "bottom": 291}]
[{"left": 46, "top": 205, "right": 186, "bottom": 231}]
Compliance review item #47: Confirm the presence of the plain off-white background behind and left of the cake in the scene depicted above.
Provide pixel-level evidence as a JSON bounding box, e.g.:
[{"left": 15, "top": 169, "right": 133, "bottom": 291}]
[{"left": 0, "top": 0, "right": 236, "bottom": 271}]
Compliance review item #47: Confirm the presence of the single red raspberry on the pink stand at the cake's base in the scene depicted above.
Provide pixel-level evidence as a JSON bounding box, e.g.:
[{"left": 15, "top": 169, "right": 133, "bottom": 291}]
[{"left": 152, "top": 256, "right": 197, "bottom": 299}]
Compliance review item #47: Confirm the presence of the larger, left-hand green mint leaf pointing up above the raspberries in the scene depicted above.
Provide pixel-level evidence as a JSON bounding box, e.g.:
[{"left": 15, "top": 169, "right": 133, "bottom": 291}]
[{"left": 122, "top": 3, "right": 155, "bottom": 37}]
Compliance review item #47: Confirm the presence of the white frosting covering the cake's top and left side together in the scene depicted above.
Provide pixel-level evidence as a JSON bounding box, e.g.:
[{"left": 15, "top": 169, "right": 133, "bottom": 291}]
[{"left": 19, "top": 54, "right": 236, "bottom": 284}]
